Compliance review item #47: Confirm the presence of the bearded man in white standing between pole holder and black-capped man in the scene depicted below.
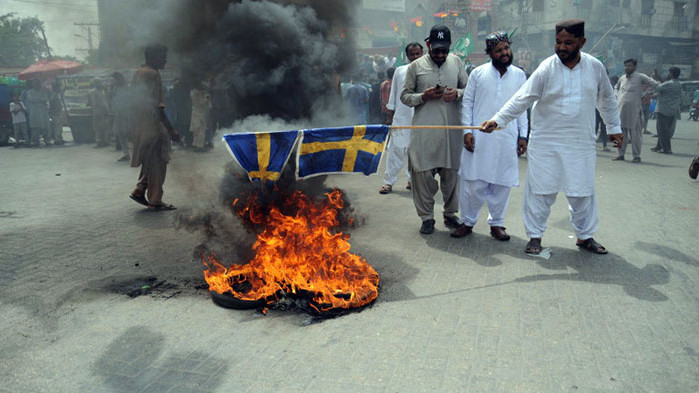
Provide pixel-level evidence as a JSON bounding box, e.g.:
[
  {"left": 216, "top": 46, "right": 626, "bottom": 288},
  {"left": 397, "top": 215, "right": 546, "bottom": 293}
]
[{"left": 451, "top": 32, "right": 529, "bottom": 241}]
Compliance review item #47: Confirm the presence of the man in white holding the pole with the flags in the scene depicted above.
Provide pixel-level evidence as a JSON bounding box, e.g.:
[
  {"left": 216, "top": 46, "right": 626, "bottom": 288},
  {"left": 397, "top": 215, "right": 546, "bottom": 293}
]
[{"left": 481, "top": 19, "right": 623, "bottom": 254}]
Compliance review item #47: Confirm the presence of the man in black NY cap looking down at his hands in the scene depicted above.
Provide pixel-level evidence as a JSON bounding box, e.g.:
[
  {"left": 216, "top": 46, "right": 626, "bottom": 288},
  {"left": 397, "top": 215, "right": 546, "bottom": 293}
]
[{"left": 400, "top": 25, "right": 468, "bottom": 234}]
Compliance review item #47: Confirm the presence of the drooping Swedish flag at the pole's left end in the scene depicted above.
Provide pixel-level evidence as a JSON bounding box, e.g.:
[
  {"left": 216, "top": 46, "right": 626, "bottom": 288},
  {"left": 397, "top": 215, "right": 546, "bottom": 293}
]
[{"left": 223, "top": 131, "right": 299, "bottom": 183}]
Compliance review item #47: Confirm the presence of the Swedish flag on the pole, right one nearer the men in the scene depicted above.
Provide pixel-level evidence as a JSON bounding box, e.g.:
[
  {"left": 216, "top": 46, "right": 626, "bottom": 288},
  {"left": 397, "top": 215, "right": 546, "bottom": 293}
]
[{"left": 298, "top": 125, "right": 389, "bottom": 179}]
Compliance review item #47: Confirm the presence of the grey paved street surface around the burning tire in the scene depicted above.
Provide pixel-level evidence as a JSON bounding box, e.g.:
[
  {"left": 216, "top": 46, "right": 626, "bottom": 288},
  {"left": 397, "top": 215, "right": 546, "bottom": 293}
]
[{"left": 0, "top": 120, "right": 699, "bottom": 393}]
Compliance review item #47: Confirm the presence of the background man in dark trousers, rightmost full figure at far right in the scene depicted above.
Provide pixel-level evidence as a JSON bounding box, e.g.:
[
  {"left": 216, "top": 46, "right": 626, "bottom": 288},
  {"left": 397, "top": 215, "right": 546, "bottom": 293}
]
[{"left": 651, "top": 67, "right": 682, "bottom": 154}]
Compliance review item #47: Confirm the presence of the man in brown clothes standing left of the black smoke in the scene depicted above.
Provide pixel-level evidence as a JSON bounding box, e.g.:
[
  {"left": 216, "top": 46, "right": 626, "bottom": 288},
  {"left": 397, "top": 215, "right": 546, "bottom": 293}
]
[{"left": 130, "top": 44, "right": 180, "bottom": 210}]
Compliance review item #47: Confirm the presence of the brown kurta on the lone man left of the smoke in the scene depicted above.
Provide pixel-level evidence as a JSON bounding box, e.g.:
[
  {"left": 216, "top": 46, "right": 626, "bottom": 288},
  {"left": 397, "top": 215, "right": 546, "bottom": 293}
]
[{"left": 131, "top": 65, "right": 170, "bottom": 167}]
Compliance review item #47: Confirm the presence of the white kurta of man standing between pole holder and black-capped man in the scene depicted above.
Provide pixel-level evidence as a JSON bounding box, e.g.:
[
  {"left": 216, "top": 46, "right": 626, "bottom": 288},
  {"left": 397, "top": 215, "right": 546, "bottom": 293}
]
[{"left": 459, "top": 62, "right": 529, "bottom": 187}]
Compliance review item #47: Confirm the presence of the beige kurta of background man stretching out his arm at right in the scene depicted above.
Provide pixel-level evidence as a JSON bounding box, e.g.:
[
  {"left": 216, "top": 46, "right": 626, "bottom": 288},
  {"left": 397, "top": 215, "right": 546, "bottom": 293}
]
[{"left": 614, "top": 72, "right": 658, "bottom": 130}]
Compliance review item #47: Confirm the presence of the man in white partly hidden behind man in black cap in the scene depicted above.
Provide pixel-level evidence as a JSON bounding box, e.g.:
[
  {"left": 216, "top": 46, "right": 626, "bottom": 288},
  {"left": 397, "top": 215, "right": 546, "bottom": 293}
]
[{"left": 379, "top": 42, "right": 422, "bottom": 194}]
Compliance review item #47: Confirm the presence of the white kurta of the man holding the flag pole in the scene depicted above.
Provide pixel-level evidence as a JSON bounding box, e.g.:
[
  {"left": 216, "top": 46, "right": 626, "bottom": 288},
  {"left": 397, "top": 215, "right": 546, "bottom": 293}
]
[{"left": 493, "top": 53, "right": 621, "bottom": 197}]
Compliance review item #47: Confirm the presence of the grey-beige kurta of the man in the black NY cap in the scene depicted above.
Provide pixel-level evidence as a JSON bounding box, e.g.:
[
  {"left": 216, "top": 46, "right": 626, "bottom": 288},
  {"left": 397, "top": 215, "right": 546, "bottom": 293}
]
[{"left": 400, "top": 54, "right": 468, "bottom": 172}]
